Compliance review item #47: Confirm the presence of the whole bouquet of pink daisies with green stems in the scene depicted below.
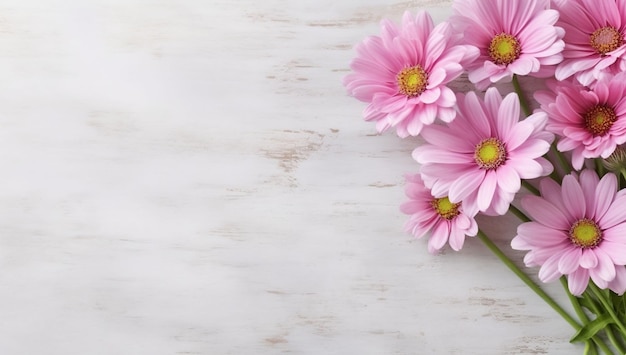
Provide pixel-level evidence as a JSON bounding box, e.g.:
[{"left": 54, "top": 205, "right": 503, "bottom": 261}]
[{"left": 344, "top": 0, "right": 626, "bottom": 354}]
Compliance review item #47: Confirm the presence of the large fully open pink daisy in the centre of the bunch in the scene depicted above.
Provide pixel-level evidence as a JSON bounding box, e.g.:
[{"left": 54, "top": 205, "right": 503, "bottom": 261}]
[{"left": 413, "top": 88, "right": 553, "bottom": 215}]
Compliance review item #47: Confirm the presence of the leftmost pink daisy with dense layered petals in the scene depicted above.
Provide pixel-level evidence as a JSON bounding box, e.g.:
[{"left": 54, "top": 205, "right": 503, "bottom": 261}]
[{"left": 343, "top": 12, "right": 478, "bottom": 137}]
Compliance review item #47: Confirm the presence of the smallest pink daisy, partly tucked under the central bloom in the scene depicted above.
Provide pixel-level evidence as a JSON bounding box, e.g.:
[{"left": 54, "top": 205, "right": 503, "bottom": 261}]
[{"left": 400, "top": 175, "right": 478, "bottom": 254}]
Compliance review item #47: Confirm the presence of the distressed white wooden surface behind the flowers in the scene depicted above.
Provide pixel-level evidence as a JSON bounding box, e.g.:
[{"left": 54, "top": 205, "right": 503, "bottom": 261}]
[{"left": 0, "top": 0, "right": 581, "bottom": 354}]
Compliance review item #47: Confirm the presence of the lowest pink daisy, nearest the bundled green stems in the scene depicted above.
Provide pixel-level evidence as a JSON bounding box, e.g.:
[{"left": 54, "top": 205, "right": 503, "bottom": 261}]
[{"left": 511, "top": 170, "right": 626, "bottom": 296}]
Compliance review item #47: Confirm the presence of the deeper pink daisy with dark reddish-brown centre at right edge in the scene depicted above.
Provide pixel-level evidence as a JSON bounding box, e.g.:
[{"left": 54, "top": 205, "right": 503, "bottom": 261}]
[{"left": 535, "top": 73, "right": 626, "bottom": 170}]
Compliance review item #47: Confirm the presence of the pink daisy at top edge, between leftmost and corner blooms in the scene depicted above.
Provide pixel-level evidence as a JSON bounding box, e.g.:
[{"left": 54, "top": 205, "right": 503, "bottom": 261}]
[{"left": 450, "top": 0, "right": 564, "bottom": 90}]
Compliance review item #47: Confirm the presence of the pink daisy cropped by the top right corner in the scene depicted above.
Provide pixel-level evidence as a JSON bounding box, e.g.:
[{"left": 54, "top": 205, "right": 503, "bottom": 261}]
[{"left": 553, "top": 0, "right": 626, "bottom": 85}]
